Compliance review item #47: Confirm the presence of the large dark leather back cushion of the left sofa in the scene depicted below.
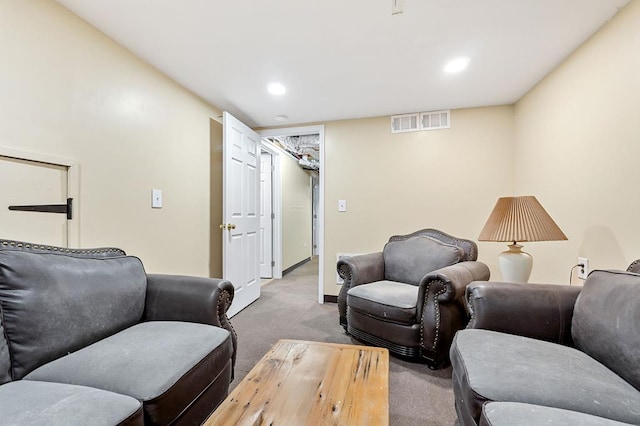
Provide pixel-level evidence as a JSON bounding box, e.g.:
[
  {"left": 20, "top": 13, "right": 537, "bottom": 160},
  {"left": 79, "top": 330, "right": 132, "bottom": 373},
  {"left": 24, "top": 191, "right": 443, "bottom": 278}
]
[{"left": 0, "top": 250, "right": 147, "bottom": 380}]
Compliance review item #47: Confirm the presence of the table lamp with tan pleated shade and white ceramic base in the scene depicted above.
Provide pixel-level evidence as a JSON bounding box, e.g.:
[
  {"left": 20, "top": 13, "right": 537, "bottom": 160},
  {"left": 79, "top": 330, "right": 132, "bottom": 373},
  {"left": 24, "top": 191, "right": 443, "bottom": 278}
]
[{"left": 478, "top": 195, "right": 567, "bottom": 283}]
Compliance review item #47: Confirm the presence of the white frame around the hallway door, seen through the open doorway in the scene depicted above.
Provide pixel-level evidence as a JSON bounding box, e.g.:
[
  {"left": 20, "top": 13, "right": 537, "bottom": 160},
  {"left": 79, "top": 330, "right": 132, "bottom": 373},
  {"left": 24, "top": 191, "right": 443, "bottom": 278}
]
[{"left": 257, "top": 141, "right": 282, "bottom": 279}]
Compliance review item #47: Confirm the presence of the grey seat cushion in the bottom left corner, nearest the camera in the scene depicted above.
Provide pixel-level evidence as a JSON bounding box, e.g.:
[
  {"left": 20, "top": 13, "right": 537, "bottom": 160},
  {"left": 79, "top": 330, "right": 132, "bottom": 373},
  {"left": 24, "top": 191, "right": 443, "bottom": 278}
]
[{"left": 0, "top": 380, "right": 144, "bottom": 426}]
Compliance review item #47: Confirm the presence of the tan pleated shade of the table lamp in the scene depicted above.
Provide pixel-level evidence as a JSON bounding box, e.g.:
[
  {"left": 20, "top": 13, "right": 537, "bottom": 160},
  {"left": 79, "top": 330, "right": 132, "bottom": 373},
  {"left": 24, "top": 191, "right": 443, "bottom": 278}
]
[{"left": 478, "top": 195, "right": 567, "bottom": 243}]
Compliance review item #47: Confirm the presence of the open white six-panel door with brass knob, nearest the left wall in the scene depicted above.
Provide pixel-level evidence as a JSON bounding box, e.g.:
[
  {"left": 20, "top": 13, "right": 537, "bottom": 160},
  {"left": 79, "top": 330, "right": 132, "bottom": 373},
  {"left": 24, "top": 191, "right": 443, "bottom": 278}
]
[{"left": 221, "top": 112, "right": 260, "bottom": 317}]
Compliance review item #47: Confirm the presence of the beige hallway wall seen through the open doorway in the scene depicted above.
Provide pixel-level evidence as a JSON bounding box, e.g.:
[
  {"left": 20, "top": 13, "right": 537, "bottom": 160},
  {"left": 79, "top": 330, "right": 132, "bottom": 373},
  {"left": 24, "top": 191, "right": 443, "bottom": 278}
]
[{"left": 280, "top": 154, "right": 312, "bottom": 270}]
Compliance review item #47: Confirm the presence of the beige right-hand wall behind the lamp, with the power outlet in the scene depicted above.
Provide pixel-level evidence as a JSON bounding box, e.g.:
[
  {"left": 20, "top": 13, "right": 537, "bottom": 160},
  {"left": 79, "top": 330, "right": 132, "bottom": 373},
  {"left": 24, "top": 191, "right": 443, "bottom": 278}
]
[{"left": 514, "top": 1, "right": 640, "bottom": 284}]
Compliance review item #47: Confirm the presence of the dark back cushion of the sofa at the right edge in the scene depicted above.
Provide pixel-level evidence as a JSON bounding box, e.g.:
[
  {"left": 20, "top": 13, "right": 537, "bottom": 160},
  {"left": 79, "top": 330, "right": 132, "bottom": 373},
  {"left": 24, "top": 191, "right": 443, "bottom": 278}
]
[{"left": 571, "top": 271, "right": 640, "bottom": 389}]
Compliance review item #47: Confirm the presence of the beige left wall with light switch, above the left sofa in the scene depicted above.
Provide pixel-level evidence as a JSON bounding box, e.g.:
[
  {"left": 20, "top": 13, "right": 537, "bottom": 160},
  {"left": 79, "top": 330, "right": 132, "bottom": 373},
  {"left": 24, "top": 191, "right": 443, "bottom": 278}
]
[{"left": 0, "top": 0, "right": 219, "bottom": 275}]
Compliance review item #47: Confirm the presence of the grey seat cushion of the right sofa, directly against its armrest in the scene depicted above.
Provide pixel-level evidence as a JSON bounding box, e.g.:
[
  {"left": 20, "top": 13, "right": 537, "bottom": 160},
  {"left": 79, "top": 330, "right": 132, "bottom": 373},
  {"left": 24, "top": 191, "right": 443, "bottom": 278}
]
[{"left": 451, "top": 329, "right": 640, "bottom": 424}]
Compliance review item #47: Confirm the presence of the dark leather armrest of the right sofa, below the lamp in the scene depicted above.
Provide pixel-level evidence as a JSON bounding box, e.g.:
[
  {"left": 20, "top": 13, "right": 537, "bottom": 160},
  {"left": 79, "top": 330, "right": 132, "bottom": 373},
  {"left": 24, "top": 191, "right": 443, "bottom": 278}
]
[{"left": 466, "top": 282, "right": 582, "bottom": 345}]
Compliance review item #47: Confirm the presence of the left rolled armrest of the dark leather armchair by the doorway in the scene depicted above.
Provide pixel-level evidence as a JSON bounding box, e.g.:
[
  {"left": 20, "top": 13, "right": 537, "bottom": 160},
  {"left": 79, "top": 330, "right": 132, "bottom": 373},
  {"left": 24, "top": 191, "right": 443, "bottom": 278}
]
[{"left": 337, "top": 252, "right": 384, "bottom": 330}]
